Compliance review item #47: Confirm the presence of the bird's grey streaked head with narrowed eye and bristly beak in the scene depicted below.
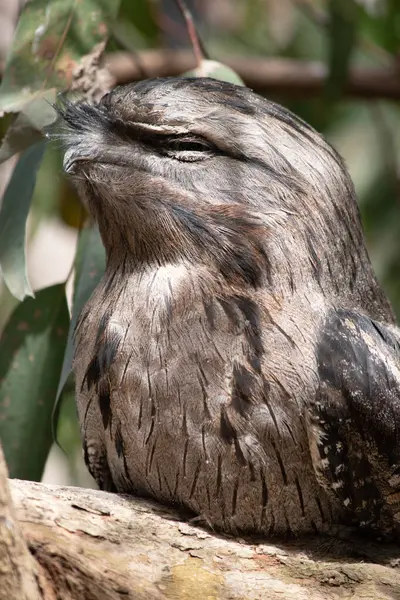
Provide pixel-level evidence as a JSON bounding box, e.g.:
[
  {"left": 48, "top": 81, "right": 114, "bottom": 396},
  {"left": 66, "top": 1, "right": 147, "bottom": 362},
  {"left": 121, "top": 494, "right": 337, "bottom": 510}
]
[{"left": 56, "top": 78, "right": 363, "bottom": 296}]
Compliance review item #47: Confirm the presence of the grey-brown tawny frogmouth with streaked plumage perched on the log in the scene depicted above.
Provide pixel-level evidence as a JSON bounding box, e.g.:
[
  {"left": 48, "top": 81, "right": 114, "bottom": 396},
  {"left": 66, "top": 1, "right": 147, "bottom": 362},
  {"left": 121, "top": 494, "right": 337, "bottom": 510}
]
[{"left": 58, "top": 77, "right": 400, "bottom": 540}]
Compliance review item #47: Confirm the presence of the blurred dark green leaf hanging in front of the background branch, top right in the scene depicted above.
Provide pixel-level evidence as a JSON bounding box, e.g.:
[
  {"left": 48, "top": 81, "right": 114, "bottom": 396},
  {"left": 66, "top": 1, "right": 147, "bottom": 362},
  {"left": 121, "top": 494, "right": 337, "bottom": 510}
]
[{"left": 325, "top": 0, "right": 361, "bottom": 102}]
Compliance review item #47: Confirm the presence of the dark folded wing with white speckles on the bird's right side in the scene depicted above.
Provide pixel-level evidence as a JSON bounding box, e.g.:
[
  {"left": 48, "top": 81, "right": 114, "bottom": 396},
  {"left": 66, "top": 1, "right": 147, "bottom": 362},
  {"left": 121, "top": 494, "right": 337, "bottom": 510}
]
[{"left": 311, "top": 310, "right": 400, "bottom": 530}]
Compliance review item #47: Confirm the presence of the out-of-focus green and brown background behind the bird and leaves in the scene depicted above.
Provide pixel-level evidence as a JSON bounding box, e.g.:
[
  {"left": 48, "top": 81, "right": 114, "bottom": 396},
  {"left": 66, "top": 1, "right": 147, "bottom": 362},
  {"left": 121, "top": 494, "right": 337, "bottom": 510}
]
[{"left": 0, "top": 0, "right": 400, "bottom": 486}]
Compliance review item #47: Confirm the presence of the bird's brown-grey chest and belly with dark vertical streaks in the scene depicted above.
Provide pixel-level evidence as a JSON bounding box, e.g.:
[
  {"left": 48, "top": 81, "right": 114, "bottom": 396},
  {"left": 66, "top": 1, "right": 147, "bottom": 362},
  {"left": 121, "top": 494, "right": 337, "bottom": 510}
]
[{"left": 75, "top": 270, "right": 328, "bottom": 530}]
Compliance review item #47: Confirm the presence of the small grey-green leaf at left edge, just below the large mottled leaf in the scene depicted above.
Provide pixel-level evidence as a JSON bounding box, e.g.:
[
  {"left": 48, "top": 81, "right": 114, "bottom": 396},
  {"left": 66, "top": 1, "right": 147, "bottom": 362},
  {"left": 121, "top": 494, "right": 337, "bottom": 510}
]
[{"left": 0, "top": 90, "right": 57, "bottom": 163}]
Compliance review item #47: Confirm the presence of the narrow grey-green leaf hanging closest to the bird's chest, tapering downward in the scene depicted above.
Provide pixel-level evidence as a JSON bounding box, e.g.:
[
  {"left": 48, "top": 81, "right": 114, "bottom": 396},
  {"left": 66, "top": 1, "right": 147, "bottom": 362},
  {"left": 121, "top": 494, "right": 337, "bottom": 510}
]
[{"left": 53, "top": 227, "right": 106, "bottom": 431}]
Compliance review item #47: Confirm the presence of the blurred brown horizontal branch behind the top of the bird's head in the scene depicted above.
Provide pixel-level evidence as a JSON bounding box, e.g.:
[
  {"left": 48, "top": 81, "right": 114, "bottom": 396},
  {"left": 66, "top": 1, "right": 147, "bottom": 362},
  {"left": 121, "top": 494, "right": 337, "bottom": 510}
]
[{"left": 106, "top": 50, "right": 400, "bottom": 100}]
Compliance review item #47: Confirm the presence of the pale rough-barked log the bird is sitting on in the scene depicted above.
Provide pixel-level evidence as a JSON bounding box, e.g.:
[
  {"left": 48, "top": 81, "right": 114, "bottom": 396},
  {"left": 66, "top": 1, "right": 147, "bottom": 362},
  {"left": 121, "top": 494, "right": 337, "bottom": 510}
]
[{"left": 0, "top": 480, "right": 400, "bottom": 600}]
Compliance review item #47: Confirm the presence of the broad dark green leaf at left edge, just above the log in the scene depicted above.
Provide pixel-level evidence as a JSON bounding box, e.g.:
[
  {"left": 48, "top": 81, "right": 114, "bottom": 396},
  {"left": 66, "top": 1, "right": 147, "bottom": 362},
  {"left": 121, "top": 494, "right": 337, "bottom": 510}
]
[{"left": 0, "top": 284, "right": 69, "bottom": 481}]
